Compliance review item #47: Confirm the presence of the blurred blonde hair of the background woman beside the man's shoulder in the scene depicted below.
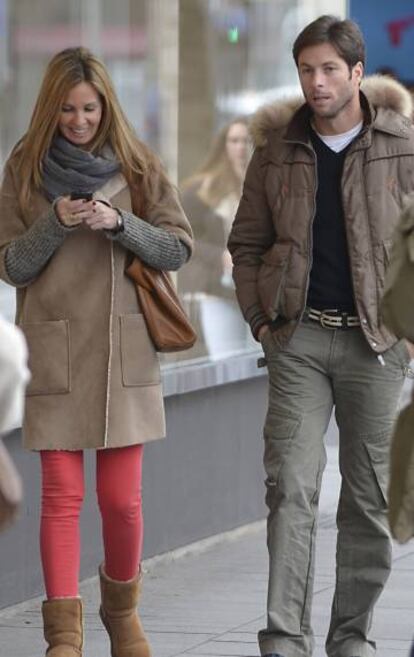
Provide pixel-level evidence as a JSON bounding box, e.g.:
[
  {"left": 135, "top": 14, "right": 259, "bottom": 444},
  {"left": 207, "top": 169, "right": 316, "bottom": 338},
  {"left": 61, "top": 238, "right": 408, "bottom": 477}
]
[{"left": 182, "top": 116, "right": 249, "bottom": 207}]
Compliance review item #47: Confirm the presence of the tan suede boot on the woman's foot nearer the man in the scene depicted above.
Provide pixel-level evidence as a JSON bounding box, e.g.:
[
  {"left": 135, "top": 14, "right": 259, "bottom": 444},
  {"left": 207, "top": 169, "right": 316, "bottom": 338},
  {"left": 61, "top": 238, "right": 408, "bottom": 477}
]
[{"left": 99, "top": 566, "right": 151, "bottom": 657}]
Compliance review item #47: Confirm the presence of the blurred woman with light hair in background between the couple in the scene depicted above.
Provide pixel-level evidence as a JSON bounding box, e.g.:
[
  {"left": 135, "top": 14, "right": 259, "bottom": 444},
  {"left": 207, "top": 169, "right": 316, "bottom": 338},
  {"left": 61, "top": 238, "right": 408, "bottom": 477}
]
[{"left": 178, "top": 117, "right": 251, "bottom": 357}]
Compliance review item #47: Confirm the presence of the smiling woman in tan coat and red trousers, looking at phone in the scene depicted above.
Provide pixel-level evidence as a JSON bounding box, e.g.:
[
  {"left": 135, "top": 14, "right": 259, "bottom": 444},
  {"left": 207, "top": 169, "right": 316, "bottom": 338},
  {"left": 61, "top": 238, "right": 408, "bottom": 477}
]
[{"left": 0, "top": 48, "right": 192, "bottom": 657}]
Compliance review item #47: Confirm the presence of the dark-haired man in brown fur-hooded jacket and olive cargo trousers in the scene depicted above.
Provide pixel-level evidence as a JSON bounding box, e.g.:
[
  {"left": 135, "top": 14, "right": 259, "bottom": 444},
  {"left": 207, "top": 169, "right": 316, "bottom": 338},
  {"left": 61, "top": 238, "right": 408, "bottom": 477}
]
[{"left": 229, "top": 16, "right": 414, "bottom": 657}]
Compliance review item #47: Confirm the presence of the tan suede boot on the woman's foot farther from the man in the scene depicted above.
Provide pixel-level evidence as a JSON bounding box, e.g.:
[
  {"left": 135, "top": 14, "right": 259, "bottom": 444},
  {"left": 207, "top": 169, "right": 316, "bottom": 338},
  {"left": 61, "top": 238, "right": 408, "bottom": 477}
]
[{"left": 42, "top": 598, "right": 83, "bottom": 657}]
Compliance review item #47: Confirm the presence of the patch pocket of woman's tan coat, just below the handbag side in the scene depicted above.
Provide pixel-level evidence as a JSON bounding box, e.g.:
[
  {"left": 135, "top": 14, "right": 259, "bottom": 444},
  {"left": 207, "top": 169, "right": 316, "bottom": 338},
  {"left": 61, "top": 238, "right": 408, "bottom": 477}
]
[{"left": 119, "top": 314, "right": 161, "bottom": 387}]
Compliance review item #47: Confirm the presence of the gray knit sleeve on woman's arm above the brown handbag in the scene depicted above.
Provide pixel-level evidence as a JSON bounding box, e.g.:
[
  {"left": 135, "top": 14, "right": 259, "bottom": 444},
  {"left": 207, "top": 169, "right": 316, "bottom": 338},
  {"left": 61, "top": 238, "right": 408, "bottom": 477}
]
[{"left": 107, "top": 210, "right": 190, "bottom": 271}]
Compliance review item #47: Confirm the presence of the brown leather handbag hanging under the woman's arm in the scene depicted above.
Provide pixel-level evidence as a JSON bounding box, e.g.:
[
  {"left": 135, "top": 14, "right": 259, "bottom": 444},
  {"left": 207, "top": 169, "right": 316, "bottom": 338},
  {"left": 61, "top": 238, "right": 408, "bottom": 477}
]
[{"left": 125, "top": 257, "right": 197, "bottom": 352}]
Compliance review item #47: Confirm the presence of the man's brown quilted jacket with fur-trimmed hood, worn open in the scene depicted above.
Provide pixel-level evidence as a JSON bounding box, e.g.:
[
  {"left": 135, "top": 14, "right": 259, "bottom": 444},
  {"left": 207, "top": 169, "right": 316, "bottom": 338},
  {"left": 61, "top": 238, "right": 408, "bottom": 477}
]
[{"left": 229, "top": 76, "right": 414, "bottom": 352}]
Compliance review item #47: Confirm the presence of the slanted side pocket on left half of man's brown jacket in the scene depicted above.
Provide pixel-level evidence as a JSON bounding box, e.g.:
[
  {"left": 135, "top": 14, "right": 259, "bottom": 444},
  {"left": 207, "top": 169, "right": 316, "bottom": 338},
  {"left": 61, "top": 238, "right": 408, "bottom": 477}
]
[{"left": 257, "top": 244, "right": 292, "bottom": 319}]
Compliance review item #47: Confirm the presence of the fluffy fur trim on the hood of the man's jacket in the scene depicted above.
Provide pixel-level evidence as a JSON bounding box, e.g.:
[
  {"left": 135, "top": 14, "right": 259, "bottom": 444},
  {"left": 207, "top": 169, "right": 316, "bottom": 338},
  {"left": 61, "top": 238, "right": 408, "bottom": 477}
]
[{"left": 250, "top": 75, "right": 414, "bottom": 146}]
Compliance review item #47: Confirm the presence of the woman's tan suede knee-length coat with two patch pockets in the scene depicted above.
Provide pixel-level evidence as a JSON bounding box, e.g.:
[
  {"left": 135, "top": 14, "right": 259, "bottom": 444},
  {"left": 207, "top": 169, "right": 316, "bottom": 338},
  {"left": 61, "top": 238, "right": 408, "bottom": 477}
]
[{"left": 0, "top": 158, "right": 191, "bottom": 450}]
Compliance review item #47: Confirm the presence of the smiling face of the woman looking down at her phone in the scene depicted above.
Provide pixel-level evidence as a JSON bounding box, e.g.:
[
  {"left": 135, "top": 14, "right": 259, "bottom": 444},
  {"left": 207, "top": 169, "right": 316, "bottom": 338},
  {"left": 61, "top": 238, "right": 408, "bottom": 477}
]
[{"left": 58, "top": 82, "right": 102, "bottom": 147}]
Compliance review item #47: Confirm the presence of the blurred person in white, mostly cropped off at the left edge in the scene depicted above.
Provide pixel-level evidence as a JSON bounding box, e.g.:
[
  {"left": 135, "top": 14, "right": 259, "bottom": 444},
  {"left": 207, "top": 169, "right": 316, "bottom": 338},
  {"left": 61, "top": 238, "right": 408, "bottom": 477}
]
[{"left": 0, "top": 317, "right": 29, "bottom": 529}]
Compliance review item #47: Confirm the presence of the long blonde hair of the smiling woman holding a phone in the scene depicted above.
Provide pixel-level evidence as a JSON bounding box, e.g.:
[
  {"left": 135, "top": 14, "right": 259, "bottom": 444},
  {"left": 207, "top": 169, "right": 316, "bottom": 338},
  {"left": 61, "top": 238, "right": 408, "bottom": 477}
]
[{"left": 15, "top": 47, "right": 164, "bottom": 208}]
